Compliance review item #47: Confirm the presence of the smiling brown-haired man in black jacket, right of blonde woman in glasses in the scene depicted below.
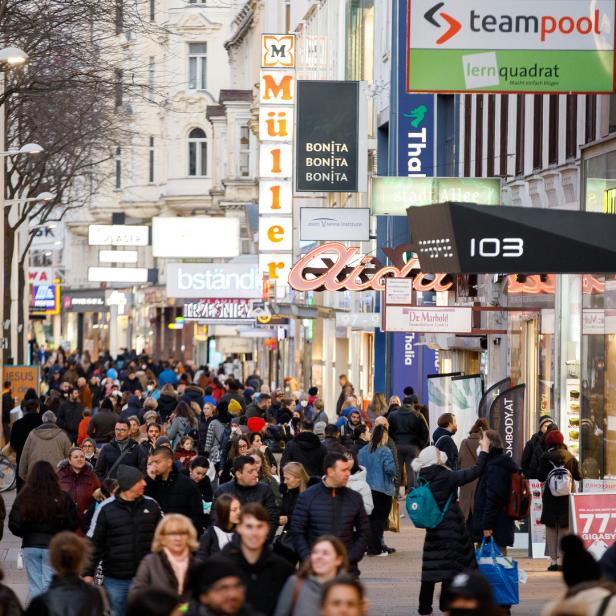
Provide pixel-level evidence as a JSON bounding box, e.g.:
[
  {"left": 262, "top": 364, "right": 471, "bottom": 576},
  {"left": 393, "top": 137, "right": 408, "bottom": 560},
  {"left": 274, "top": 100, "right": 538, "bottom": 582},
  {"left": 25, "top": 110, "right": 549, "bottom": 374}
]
[{"left": 221, "top": 503, "right": 294, "bottom": 615}]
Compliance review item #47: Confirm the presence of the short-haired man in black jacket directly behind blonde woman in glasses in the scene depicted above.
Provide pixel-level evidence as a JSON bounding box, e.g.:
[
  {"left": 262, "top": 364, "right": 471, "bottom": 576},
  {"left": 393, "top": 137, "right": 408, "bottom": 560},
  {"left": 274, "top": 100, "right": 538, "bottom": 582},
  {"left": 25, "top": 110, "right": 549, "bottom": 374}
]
[{"left": 145, "top": 447, "right": 204, "bottom": 536}]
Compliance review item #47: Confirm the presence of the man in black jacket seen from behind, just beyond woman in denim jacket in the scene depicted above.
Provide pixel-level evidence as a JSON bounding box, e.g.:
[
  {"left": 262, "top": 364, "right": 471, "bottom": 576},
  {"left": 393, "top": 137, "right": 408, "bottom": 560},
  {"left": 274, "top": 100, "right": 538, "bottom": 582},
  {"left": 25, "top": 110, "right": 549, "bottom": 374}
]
[{"left": 387, "top": 398, "right": 430, "bottom": 492}]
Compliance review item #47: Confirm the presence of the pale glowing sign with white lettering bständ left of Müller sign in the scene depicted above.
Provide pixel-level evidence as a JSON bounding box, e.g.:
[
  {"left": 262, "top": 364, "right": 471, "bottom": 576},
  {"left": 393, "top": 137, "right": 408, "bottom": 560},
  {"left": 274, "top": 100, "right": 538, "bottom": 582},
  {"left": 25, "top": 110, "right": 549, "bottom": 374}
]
[{"left": 167, "top": 261, "right": 261, "bottom": 299}]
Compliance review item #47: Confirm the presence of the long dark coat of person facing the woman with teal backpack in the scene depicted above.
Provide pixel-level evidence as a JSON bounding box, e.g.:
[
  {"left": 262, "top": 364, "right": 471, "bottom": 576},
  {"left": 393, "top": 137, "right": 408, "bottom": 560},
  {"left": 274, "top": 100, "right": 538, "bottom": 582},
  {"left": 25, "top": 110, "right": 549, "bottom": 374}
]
[{"left": 473, "top": 449, "right": 518, "bottom": 546}]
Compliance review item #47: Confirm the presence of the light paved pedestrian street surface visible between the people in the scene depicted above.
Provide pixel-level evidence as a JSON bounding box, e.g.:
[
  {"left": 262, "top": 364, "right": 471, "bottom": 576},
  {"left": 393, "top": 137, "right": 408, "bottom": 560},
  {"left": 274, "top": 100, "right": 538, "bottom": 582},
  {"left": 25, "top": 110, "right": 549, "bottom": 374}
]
[{"left": 0, "top": 490, "right": 564, "bottom": 616}]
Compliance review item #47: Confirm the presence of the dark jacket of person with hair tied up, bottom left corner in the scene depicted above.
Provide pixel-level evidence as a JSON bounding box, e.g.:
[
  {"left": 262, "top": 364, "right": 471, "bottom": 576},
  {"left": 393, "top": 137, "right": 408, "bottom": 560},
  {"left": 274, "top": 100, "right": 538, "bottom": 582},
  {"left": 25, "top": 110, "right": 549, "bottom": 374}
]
[{"left": 26, "top": 575, "right": 108, "bottom": 616}]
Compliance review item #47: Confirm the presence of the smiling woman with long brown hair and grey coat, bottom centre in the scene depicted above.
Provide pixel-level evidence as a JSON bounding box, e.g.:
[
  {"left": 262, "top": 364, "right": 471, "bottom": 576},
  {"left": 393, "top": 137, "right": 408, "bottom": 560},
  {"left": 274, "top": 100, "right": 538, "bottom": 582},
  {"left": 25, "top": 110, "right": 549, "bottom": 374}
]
[{"left": 274, "top": 535, "right": 349, "bottom": 616}]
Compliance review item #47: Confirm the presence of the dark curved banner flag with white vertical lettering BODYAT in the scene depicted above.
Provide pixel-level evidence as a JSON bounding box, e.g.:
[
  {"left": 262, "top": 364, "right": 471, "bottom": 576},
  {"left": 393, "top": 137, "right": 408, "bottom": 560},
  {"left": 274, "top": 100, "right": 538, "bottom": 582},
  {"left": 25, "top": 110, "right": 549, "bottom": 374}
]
[{"left": 488, "top": 385, "right": 526, "bottom": 465}]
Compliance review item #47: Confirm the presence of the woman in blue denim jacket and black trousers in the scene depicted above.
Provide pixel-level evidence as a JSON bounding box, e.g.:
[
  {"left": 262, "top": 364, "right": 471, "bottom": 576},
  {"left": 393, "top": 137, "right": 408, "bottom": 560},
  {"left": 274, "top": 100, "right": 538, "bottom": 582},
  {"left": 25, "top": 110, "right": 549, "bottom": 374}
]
[{"left": 357, "top": 426, "right": 396, "bottom": 556}]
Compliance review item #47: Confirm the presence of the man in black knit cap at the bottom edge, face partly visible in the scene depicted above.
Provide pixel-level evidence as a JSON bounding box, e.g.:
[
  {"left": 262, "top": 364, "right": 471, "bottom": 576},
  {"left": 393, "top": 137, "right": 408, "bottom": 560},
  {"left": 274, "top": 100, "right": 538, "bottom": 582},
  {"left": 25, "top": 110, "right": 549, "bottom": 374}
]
[{"left": 186, "top": 555, "right": 264, "bottom": 616}]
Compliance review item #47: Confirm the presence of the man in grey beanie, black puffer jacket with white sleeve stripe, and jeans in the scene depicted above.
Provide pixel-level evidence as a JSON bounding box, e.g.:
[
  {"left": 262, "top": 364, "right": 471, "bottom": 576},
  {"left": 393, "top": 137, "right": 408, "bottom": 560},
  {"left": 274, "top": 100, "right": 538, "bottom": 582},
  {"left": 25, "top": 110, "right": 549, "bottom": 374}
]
[{"left": 84, "top": 464, "right": 162, "bottom": 616}]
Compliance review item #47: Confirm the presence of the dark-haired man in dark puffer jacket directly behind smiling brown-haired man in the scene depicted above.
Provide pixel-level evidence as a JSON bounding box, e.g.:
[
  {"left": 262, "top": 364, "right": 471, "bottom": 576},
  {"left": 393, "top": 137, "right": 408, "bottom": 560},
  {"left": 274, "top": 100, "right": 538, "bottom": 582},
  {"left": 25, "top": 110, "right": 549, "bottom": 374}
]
[{"left": 214, "top": 456, "right": 279, "bottom": 541}]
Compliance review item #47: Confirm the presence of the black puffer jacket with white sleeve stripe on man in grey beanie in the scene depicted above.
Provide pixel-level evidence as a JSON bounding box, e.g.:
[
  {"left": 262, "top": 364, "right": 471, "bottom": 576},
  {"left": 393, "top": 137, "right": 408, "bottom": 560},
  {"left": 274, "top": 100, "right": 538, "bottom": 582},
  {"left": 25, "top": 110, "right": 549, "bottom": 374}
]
[{"left": 84, "top": 496, "right": 162, "bottom": 580}]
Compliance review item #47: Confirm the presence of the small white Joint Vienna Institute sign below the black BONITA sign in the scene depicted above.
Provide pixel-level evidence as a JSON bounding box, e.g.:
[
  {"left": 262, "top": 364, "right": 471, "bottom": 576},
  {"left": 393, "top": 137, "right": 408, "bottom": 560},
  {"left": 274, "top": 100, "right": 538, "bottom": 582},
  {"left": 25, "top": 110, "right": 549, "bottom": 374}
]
[{"left": 299, "top": 207, "right": 370, "bottom": 242}]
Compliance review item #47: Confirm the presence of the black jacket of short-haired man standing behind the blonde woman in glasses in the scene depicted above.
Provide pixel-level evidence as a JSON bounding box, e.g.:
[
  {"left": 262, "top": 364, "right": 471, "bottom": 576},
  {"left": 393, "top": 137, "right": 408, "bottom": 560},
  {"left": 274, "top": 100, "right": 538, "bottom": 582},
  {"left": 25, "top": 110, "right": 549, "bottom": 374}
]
[{"left": 145, "top": 470, "right": 205, "bottom": 536}]
